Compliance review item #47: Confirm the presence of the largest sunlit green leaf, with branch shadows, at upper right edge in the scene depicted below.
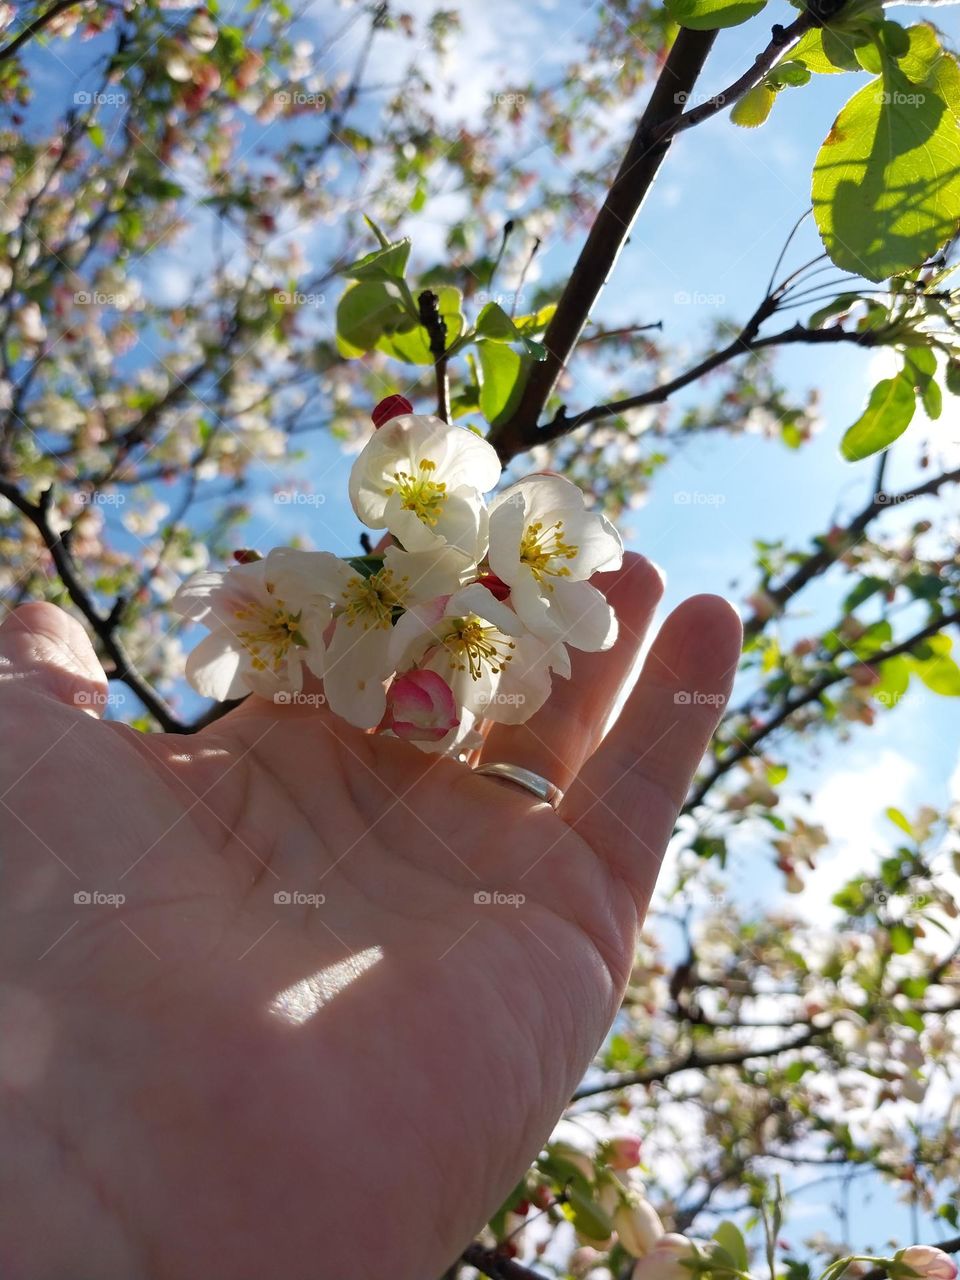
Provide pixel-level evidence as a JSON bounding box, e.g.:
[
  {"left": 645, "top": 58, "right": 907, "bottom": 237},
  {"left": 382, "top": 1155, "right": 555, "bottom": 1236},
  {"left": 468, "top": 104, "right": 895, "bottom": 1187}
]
[{"left": 813, "top": 55, "right": 960, "bottom": 280}]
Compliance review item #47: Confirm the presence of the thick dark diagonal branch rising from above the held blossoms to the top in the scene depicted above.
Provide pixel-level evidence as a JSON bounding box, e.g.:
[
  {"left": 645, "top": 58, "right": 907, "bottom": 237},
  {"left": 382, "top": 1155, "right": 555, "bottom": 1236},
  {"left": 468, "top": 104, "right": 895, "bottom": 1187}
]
[{"left": 490, "top": 29, "right": 717, "bottom": 458}]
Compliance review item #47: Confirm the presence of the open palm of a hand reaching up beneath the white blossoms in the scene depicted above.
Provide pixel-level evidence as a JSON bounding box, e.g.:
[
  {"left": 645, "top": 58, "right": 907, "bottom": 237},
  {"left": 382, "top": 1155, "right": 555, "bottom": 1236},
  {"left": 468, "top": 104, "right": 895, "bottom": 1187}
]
[{"left": 0, "top": 556, "right": 740, "bottom": 1280}]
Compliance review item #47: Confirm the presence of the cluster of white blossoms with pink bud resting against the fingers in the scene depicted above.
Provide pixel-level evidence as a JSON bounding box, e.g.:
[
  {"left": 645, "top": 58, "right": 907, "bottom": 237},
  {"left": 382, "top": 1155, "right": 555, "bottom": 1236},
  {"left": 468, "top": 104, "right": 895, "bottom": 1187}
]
[{"left": 174, "top": 397, "right": 623, "bottom": 751}]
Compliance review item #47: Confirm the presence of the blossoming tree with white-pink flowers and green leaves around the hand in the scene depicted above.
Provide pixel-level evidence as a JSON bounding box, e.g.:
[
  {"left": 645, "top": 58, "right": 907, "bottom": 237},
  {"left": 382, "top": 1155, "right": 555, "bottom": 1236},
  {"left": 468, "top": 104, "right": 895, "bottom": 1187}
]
[{"left": 0, "top": 0, "right": 960, "bottom": 1280}]
